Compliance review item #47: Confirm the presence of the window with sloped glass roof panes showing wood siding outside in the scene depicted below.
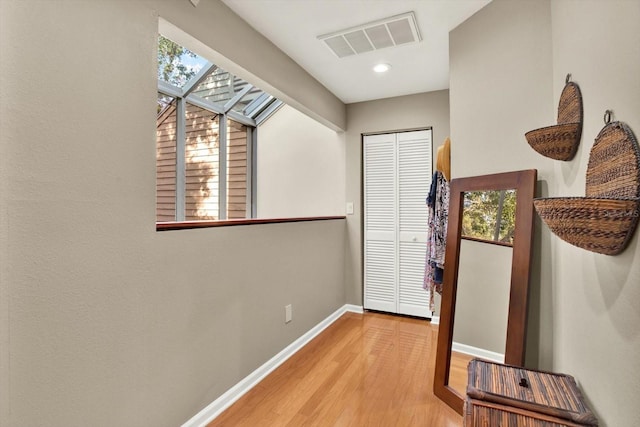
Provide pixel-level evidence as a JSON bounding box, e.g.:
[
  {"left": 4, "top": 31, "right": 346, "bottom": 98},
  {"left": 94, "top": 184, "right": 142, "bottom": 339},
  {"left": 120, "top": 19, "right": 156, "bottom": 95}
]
[{"left": 156, "top": 35, "right": 282, "bottom": 222}]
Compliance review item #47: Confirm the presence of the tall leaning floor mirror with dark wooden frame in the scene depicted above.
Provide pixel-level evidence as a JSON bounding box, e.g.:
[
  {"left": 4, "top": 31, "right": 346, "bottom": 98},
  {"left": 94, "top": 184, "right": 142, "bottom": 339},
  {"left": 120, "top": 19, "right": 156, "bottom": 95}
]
[{"left": 433, "top": 169, "right": 537, "bottom": 414}]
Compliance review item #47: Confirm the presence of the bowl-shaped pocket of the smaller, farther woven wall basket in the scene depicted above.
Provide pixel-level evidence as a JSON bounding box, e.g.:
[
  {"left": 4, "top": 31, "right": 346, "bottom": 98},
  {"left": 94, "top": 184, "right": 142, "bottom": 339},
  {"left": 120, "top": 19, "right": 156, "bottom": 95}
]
[{"left": 524, "top": 123, "right": 582, "bottom": 160}]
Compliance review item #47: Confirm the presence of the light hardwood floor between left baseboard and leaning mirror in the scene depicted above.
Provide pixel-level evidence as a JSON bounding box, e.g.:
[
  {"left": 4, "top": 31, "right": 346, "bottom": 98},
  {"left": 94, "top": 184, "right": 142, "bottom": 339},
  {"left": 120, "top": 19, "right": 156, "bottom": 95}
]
[{"left": 209, "top": 312, "right": 462, "bottom": 427}]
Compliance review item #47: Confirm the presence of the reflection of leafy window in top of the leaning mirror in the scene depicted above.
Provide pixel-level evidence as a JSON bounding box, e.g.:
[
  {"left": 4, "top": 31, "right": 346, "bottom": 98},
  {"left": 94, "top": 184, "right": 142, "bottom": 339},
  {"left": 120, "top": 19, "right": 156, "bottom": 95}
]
[{"left": 462, "top": 189, "right": 516, "bottom": 246}]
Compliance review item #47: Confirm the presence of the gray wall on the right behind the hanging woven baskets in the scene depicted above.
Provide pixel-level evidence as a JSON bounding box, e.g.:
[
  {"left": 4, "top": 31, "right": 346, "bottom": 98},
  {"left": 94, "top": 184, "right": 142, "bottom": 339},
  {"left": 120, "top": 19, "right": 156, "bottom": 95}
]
[{"left": 450, "top": 0, "right": 640, "bottom": 426}]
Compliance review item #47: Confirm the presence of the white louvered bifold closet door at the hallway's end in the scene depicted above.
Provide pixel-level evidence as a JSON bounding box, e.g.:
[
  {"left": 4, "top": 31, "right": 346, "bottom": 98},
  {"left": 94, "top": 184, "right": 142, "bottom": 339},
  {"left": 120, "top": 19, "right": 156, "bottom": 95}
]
[{"left": 363, "top": 130, "right": 432, "bottom": 317}]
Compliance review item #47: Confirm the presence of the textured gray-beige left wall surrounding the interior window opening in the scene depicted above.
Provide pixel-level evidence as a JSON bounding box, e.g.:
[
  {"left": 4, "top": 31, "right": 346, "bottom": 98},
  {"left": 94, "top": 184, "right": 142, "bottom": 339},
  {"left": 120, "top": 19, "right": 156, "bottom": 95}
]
[{"left": 0, "top": 0, "right": 346, "bottom": 427}]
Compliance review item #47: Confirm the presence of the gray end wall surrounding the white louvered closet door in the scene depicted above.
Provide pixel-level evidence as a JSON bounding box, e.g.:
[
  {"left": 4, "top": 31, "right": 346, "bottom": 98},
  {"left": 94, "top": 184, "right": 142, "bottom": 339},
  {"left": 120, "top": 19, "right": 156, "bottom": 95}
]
[{"left": 345, "top": 90, "right": 449, "bottom": 305}]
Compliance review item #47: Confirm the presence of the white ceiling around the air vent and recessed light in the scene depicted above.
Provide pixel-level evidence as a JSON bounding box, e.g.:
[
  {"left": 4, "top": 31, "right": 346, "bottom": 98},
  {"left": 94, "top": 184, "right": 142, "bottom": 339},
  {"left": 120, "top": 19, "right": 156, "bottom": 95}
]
[{"left": 222, "top": 0, "right": 490, "bottom": 104}]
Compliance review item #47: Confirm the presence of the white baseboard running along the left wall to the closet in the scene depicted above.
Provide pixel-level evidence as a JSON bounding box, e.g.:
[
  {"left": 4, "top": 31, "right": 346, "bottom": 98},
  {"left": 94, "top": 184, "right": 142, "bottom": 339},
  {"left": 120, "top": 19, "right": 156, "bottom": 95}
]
[{"left": 182, "top": 304, "right": 364, "bottom": 427}]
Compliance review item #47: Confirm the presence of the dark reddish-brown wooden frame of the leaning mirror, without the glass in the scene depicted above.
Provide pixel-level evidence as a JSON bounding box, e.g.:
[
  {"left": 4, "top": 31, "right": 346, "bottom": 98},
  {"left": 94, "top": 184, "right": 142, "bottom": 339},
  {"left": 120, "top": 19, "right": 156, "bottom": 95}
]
[{"left": 433, "top": 169, "right": 537, "bottom": 414}]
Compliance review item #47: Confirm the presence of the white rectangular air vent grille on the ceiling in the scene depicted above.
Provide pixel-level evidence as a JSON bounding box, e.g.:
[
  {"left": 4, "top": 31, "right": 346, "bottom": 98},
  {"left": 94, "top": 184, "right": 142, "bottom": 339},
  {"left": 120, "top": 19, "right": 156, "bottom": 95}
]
[{"left": 318, "top": 12, "right": 421, "bottom": 58}]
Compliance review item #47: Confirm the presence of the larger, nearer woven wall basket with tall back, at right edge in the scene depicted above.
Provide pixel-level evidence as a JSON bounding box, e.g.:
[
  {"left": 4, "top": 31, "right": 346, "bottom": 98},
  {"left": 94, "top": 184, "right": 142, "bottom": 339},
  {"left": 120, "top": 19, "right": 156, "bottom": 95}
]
[{"left": 533, "top": 111, "right": 640, "bottom": 255}]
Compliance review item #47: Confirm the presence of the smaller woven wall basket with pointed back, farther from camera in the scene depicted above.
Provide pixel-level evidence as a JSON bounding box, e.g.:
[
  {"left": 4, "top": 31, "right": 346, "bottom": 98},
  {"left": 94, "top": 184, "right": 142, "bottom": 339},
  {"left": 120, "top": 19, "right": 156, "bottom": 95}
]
[{"left": 524, "top": 74, "right": 583, "bottom": 160}]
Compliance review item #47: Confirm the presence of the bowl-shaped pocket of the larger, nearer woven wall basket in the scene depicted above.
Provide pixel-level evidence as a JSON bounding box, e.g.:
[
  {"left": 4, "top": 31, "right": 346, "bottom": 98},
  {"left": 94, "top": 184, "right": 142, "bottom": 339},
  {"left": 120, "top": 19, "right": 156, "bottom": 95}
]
[{"left": 533, "top": 197, "right": 640, "bottom": 255}]
